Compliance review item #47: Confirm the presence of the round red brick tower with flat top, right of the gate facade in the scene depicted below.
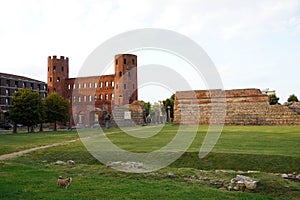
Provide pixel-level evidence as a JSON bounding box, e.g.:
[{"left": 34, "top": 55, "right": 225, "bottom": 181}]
[{"left": 114, "top": 54, "right": 138, "bottom": 106}]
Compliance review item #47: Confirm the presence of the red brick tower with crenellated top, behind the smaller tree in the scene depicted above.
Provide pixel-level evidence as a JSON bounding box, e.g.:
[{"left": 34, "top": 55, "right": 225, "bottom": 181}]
[{"left": 47, "top": 56, "right": 69, "bottom": 98}]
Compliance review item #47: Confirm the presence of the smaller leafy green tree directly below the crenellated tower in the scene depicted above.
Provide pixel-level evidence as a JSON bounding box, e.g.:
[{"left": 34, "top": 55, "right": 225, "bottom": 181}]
[{"left": 45, "top": 93, "right": 70, "bottom": 131}]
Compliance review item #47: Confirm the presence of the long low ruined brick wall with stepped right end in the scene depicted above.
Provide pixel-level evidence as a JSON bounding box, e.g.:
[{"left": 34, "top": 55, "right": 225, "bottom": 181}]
[{"left": 174, "top": 89, "right": 300, "bottom": 125}]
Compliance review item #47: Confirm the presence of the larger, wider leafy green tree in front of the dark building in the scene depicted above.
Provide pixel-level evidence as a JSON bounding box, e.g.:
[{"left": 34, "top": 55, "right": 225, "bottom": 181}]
[{"left": 8, "top": 88, "right": 45, "bottom": 133}]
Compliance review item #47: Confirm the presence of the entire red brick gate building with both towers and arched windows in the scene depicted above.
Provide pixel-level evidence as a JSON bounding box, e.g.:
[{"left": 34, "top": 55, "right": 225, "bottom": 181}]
[{"left": 47, "top": 54, "right": 138, "bottom": 126}]
